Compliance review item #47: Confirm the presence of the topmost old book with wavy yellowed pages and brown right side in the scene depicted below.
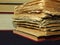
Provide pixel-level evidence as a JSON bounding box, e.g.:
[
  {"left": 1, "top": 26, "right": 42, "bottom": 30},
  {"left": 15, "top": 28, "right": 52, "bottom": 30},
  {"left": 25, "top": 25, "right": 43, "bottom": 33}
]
[{"left": 15, "top": 0, "right": 60, "bottom": 15}]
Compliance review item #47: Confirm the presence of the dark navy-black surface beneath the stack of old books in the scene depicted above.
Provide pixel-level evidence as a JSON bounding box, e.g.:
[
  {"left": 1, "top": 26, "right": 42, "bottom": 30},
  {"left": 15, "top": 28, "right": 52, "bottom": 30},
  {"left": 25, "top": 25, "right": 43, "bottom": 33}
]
[{"left": 0, "top": 31, "right": 60, "bottom": 45}]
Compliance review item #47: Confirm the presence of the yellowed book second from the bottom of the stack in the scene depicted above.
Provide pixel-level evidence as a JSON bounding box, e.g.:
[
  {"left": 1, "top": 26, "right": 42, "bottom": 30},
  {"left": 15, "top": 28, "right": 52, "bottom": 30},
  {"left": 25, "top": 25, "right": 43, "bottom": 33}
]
[{"left": 16, "top": 27, "right": 60, "bottom": 37}]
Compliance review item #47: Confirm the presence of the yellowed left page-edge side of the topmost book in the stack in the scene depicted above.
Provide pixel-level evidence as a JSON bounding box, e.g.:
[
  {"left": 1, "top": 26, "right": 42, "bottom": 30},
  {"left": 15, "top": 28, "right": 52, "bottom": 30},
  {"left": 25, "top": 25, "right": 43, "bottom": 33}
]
[{"left": 15, "top": 0, "right": 44, "bottom": 15}]
